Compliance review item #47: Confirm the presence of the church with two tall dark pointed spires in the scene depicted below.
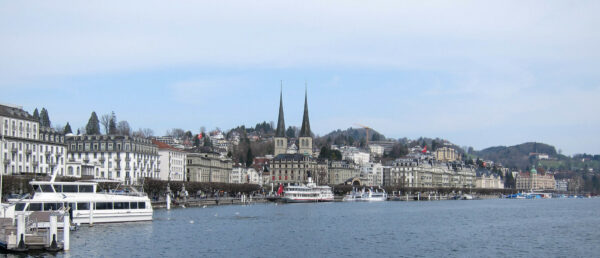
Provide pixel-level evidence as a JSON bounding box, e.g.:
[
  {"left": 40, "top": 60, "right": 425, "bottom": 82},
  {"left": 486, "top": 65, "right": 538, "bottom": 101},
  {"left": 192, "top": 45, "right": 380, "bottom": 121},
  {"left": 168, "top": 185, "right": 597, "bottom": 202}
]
[{"left": 270, "top": 87, "right": 317, "bottom": 183}]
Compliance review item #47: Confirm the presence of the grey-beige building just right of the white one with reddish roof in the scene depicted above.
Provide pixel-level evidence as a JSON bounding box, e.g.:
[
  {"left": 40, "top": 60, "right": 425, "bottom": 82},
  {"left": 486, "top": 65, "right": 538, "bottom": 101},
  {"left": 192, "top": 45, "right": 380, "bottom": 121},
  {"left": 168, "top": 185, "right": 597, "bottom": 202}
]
[{"left": 186, "top": 153, "right": 233, "bottom": 183}]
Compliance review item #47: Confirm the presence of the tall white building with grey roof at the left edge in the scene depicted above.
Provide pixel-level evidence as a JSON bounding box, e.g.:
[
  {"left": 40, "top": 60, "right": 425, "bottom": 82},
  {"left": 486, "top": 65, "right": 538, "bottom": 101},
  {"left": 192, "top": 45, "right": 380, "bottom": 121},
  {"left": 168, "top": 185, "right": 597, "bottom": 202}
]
[{"left": 0, "top": 105, "right": 66, "bottom": 175}]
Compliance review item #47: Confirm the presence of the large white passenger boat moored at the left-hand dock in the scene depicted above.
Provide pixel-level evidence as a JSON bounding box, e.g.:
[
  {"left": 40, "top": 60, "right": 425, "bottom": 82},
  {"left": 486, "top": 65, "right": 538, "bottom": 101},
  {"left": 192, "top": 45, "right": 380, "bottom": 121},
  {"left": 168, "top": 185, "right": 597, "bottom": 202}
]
[{"left": 0, "top": 180, "right": 153, "bottom": 224}]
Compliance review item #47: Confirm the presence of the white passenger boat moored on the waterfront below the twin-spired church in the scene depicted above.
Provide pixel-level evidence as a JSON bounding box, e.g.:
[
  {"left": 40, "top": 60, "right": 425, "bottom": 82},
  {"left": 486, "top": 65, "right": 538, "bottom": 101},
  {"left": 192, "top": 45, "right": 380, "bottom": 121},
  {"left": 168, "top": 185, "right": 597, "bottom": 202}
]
[{"left": 282, "top": 177, "right": 333, "bottom": 202}]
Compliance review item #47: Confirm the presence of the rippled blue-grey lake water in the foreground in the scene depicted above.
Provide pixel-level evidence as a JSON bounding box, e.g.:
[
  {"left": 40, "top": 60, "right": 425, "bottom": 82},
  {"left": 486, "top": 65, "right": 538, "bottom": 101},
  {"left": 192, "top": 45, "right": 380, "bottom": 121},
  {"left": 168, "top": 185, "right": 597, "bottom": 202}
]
[{"left": 7, "top": 198, "right": 600, "bottom": 257}]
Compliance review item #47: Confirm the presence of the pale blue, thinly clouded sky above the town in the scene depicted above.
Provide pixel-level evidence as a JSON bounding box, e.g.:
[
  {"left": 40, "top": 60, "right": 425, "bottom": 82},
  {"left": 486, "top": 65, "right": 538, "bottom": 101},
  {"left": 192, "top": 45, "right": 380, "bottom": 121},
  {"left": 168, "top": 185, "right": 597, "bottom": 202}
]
[{"left": 0, "top": 0, "right": 600, "bottom": 154}]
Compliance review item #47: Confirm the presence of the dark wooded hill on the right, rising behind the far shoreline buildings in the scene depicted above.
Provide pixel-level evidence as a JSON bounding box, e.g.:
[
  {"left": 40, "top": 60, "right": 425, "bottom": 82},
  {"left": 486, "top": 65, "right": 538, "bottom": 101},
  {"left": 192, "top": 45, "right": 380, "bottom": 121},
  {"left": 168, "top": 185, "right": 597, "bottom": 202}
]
[{"left": 474, "top": 142, "right": 557, "bottom": 169}]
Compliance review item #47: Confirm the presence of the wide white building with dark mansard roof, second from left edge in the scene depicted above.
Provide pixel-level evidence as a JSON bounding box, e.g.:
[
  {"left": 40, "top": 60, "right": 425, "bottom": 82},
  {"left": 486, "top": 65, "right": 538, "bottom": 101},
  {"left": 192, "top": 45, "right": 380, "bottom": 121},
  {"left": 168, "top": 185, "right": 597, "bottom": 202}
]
[{"left": 66, "top": 135, "right": 160, "bottom": 184}]
